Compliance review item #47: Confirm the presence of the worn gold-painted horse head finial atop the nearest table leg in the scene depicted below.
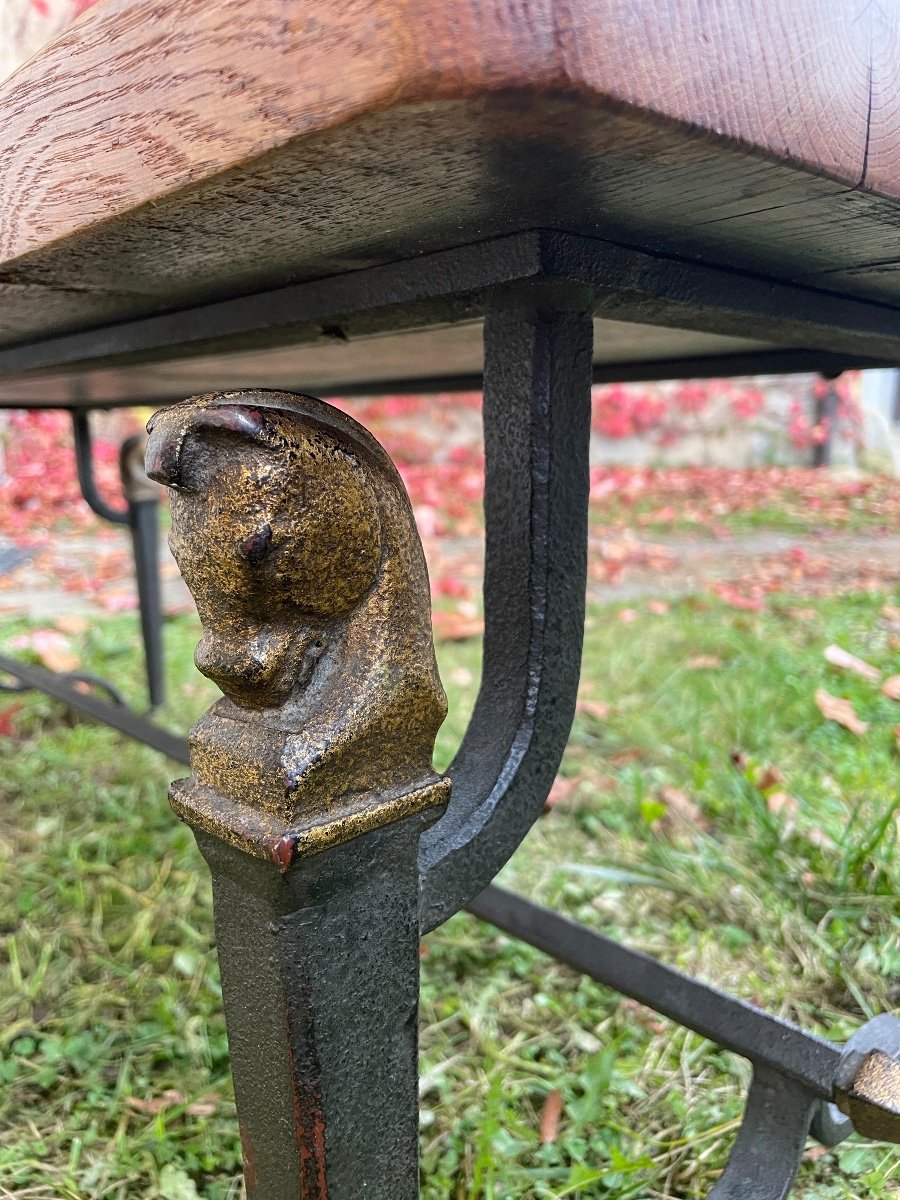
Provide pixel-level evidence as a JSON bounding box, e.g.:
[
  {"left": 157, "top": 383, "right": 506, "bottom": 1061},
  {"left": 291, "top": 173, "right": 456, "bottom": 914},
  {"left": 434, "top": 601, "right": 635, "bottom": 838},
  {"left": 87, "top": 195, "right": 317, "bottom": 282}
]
[{"left": 146, "top": 391, "right": 450, "bottom": 870}]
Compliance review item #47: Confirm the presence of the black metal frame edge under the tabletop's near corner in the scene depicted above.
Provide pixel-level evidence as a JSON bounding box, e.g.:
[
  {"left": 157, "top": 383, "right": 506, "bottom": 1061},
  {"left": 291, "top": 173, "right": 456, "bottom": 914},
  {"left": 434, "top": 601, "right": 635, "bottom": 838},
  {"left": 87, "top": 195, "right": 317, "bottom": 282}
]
[{"left": 0, "top": 230, "right": 900, "bottom": 391}]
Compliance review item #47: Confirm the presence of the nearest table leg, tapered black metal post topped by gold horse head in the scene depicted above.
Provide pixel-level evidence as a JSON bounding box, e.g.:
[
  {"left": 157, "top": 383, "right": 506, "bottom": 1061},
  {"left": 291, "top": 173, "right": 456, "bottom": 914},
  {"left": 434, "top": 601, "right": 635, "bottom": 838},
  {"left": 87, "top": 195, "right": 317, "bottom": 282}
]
[{"left": 148, "top": 392, "right": 450, "bottom": 1200}]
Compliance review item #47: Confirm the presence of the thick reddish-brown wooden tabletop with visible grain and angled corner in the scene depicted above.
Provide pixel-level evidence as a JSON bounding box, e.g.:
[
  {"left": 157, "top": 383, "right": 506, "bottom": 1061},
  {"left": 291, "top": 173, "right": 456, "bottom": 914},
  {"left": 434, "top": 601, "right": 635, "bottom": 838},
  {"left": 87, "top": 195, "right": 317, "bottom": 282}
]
[{"left": 0, "top": 0, "right": 900, "bottom": 400}]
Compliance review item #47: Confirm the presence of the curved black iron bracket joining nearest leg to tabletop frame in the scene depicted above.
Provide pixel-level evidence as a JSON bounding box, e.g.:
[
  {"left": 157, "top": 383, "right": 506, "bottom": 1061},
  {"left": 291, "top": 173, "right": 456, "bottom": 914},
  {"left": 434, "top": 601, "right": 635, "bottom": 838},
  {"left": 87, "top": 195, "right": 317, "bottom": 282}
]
[{"left": 420, "top": 298, "right": 592, "bottom": 932}]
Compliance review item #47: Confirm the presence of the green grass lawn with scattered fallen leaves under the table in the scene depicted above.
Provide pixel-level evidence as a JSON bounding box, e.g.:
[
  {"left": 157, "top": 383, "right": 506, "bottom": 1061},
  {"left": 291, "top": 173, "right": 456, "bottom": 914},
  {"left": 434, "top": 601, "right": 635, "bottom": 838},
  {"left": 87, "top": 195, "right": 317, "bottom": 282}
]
[{"left": 0, "top": 596, "right": 900, "bottom": 1200}]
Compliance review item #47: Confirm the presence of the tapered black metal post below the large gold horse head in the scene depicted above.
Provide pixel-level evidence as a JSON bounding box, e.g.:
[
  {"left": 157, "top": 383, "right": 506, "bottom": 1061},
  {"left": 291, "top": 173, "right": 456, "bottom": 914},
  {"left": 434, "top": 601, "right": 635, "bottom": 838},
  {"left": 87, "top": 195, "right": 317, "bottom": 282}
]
[{"left": 194, "top": 814, "right": 432, "bottom": 1200}]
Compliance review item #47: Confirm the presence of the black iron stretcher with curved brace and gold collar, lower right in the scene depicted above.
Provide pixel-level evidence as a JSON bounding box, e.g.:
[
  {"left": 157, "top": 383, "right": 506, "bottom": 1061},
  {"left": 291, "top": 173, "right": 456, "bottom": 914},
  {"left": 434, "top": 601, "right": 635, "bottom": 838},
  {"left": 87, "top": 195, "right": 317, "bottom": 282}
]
[{"left": 468, "top": 887, "right": 900, "bottom": 1200}]
